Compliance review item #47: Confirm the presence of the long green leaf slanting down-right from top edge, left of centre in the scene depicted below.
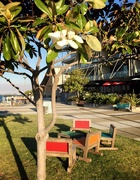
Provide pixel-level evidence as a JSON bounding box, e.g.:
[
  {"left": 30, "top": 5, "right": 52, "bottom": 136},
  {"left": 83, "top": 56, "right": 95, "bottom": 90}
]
[{"left": 34, "top": 0, "right": 53, "bottom": 20}]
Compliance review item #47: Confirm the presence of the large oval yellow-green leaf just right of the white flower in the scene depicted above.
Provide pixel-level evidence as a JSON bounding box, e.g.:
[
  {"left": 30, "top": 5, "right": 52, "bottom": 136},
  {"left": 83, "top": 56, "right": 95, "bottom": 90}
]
[{"left": 86, "top": 35, "right": 101, "bottom": 51}]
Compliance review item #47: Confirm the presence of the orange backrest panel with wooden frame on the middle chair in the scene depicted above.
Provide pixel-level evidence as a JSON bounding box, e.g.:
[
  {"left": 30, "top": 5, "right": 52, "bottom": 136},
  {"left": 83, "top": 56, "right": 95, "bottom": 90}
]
[{"left": 85, "top": 131, "right": 101, "bottom": 149}]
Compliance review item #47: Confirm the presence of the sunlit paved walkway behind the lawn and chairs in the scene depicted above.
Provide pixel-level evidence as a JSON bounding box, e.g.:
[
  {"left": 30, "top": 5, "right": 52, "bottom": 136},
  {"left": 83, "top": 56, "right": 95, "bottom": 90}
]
[{"left": 0, "top": 103, "right": 140, "bottom": 141}]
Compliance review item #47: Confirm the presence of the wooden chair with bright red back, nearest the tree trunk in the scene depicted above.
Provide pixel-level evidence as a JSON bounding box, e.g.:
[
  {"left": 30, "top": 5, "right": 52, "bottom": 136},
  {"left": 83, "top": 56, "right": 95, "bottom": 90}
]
[{"left": 46, "top": 138, "right": 76, "bottom": 173}]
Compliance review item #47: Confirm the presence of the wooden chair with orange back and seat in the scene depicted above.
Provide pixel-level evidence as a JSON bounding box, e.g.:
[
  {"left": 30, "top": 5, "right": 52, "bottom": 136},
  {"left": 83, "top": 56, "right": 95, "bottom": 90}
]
[{"left": 73, "top": 132, "right": 103, "bottom": 162}]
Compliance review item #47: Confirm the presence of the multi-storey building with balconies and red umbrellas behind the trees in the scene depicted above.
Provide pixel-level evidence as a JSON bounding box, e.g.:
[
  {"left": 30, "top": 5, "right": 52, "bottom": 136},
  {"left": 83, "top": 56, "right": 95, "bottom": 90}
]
[{"left": 64, "top": 52, "right": 140, "bottom": 94}]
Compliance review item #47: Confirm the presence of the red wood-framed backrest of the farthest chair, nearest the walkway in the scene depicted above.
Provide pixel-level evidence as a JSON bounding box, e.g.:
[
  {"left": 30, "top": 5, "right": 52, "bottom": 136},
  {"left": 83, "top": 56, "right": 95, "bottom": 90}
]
[{"left": 70, "top": 119, "right": 91, "bottom": 132}]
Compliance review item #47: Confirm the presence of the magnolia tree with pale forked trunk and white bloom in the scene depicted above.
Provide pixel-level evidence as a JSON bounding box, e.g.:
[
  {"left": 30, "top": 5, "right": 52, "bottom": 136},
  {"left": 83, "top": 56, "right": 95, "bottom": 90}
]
[{"left": 0, "top": 0, "right": 139, "bottom": 180}]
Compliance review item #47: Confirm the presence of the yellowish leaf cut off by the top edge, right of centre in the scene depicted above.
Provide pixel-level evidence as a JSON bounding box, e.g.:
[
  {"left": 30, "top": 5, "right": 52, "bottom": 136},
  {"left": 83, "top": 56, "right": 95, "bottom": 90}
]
[{"left": 85, "top": 0, "right": 106, "bottom": 9}]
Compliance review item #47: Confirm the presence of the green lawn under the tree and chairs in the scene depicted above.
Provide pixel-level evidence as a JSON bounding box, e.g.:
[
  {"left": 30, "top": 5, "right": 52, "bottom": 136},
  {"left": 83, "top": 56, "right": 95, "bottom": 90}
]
[{"left": 0, "top": 115, "right": 140, "bottom": 180}]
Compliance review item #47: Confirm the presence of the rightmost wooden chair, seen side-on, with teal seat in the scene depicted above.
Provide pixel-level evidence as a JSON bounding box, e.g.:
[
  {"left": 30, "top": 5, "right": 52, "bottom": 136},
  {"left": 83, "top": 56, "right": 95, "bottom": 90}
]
[{"left": 99, "top": 124, "right": 118, "bottom": 150}]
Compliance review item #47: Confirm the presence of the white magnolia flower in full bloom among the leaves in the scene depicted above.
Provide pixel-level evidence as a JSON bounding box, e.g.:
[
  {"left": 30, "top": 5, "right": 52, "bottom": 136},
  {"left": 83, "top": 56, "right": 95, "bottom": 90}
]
[{"left": 48, "top": 30, "right": 83, "bottom": 49}]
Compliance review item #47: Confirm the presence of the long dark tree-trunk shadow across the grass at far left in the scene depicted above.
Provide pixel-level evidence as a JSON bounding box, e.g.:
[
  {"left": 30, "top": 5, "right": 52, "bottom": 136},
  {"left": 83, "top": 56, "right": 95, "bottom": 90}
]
[{"left": 0, "top": 114, "right": 30, "bottom": 180}]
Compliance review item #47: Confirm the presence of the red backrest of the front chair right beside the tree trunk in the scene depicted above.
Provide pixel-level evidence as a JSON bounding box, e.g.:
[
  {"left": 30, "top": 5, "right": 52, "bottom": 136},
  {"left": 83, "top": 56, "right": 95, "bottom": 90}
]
[{"left": 46, "top": 138, "right": 72, "bottom": 153}]
